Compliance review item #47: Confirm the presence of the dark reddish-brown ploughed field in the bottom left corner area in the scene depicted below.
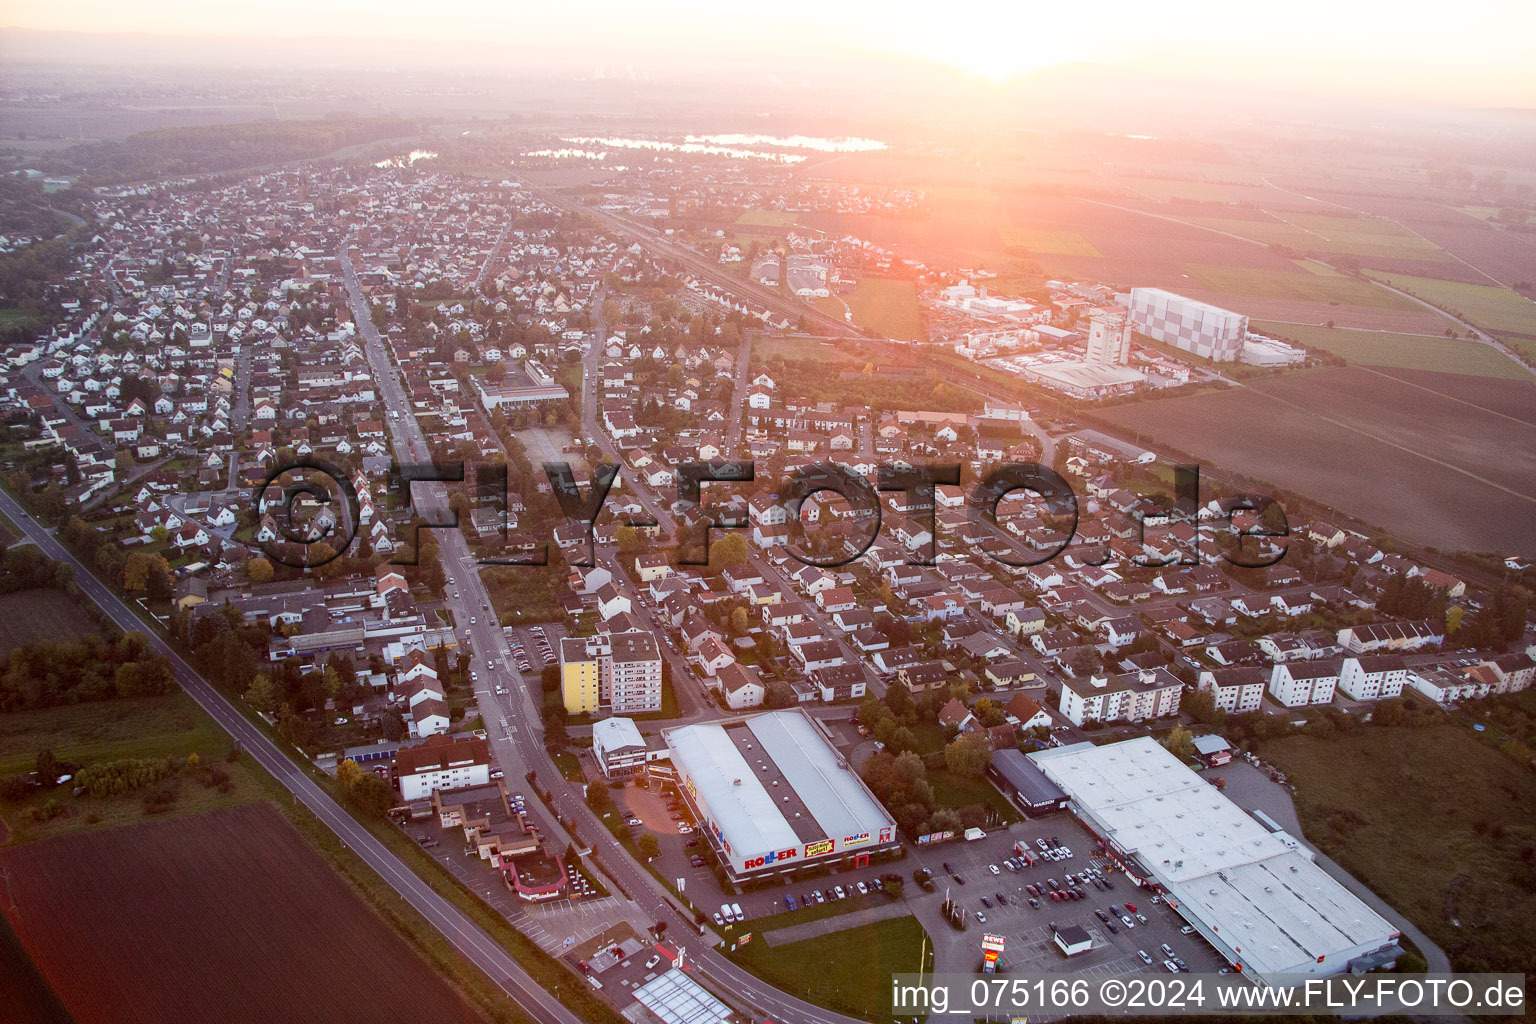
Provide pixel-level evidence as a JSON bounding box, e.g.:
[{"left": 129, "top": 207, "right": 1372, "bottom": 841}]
[{"left": 0, "top": 803, "right": 482, "bottom": 1024}]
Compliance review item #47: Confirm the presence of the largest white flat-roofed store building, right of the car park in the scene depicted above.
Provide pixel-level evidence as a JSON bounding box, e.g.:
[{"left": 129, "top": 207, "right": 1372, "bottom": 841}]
[{"left": 1029, "top": 737, "right": 1401, "bottom": 979}]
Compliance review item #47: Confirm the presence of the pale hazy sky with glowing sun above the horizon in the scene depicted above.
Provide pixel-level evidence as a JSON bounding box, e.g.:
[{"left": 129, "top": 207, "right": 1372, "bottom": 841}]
[{"left": 0, "top": 0, "right": 1536, "bottom": 106}]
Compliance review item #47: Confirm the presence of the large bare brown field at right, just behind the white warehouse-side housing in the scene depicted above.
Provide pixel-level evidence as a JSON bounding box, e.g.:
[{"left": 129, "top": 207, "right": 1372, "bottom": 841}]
[{"left": 1101, "top": 367, "right": 1536, "bottom": 554}]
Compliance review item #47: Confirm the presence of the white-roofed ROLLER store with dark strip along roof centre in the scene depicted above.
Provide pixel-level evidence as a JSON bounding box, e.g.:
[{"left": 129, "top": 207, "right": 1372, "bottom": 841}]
[{"left": 662, "top": 711, "right": 895, "bottom": 880}]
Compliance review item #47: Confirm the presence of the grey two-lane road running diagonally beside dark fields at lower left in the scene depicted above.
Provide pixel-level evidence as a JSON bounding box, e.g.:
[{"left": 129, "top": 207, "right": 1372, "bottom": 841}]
[{"left": 0, "top": 493, "right": 581, "bottom": 1024}]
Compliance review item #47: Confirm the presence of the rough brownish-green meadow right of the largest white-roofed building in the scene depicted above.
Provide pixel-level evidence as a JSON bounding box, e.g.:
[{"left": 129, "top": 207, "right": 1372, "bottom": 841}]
[{"left": 1264, "top": 723, "right": 1536, "bottom": 972}]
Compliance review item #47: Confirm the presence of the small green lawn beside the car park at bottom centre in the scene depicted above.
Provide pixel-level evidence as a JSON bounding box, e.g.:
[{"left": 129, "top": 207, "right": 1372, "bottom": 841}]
[{"left": 730, "top": 917, "right": 932, "bottom": 1019}]
